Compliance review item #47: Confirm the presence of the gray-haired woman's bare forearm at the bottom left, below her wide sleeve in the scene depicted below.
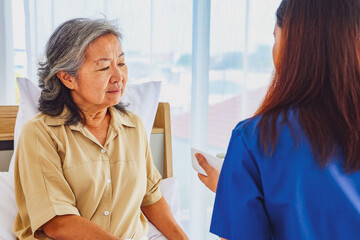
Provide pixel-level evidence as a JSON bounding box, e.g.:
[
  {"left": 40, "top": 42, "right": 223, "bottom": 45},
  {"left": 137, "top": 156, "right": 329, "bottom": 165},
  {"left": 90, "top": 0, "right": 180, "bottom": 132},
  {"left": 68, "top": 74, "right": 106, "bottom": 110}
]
[{"left": 41, "top": 215, "right": 119, "bottom": 240}]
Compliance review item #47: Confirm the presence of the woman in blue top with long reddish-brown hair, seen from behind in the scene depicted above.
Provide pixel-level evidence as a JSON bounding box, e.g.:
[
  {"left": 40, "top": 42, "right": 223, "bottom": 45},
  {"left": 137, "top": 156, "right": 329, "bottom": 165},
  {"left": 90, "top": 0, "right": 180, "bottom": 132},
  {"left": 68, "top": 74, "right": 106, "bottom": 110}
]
[{"left": 197, "top": 0, "right": 360, "bottom": 240}]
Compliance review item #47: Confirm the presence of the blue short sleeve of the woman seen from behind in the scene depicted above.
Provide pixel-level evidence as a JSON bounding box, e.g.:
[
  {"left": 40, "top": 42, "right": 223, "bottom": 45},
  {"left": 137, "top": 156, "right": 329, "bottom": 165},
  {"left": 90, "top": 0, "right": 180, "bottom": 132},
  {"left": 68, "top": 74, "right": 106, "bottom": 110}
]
[{"left": 210, "top": 130, "right": 271, "bottom": 240}]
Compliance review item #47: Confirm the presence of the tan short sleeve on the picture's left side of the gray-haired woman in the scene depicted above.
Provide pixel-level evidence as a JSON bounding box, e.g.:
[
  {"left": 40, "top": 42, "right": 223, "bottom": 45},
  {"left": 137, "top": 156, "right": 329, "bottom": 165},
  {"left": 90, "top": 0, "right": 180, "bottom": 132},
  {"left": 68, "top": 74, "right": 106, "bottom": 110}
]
[{"left": 14, "top": 121, "right": 79, "bottom": 233}]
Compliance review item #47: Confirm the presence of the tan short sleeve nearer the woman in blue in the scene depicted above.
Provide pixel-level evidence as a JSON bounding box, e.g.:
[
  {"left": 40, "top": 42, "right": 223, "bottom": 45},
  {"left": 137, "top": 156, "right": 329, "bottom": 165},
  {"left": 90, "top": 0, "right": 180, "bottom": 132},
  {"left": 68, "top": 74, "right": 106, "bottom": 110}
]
[{"left": 141, "top": 118, "right": 162, "bottom": 207}]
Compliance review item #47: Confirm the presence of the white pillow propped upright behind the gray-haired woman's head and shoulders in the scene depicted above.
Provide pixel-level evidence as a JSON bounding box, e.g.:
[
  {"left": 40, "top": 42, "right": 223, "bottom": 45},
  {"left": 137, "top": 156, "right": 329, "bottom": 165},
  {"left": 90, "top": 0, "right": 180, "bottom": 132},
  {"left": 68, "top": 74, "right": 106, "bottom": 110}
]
[{"left": 9, "top": 78, "right": 161, "bottom": 173}]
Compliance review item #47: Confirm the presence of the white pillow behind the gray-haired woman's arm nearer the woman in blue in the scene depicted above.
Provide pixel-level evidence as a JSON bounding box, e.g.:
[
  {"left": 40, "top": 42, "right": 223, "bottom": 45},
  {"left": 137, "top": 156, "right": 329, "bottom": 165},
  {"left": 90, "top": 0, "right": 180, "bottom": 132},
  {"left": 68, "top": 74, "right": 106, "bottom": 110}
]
[{"left": 148, "top": 177, "right": 181, "bottom": 240}]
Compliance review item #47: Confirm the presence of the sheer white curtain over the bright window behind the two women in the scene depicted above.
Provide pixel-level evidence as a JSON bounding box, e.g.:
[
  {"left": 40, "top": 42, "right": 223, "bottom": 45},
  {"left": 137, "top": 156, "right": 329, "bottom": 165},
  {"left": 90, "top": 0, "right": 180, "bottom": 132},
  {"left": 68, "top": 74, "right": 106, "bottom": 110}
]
[{"left": 9, "top": 0, "right": 280, "bottom": 240}]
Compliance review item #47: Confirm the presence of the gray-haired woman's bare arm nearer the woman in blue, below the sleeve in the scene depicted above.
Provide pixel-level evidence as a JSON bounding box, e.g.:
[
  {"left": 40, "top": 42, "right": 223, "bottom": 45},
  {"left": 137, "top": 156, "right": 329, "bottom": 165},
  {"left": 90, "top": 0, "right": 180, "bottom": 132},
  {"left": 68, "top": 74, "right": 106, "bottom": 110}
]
[{"left": 141, "top": 197, "right": 189, "bottom": 240}]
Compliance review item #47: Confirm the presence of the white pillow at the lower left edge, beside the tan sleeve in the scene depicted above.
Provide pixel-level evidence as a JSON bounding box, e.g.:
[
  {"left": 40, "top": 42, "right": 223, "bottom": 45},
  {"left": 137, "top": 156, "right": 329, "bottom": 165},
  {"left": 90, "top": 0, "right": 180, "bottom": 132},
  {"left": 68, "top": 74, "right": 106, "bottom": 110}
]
[{"left": 0, "top": 172, "right": 18, "bottom": 239}]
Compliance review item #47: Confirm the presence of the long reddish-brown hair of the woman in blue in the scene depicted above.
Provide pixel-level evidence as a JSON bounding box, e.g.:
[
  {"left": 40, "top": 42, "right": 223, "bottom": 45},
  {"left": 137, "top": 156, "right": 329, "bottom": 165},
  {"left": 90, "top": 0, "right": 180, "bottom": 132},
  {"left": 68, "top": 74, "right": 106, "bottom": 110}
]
[{"left": 255, "top": 0, "right": 360, "bottom": 172}]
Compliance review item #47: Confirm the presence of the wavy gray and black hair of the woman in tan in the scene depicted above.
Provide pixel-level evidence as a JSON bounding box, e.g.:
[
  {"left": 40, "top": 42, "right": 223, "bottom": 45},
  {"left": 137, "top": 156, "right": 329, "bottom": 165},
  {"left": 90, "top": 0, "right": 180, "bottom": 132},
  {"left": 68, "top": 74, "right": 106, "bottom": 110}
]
[{"left": 38, "top": 18, "right": 126, "bottom": 124}]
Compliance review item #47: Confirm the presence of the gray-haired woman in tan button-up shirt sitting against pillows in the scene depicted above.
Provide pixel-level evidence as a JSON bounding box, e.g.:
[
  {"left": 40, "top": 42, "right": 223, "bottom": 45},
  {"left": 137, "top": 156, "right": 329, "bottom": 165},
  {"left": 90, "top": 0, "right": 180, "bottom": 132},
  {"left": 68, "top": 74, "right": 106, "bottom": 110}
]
[{"left": 14, "top": 19, "right": 187, "bottom": 239}]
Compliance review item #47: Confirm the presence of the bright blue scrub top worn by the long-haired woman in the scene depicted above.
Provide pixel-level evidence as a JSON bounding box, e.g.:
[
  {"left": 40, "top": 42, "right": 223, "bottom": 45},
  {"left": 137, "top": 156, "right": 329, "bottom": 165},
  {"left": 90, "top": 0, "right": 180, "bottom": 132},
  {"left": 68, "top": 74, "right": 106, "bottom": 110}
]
[{"left": 210, "top": 112, "right": 360, "bottom": 240}]
